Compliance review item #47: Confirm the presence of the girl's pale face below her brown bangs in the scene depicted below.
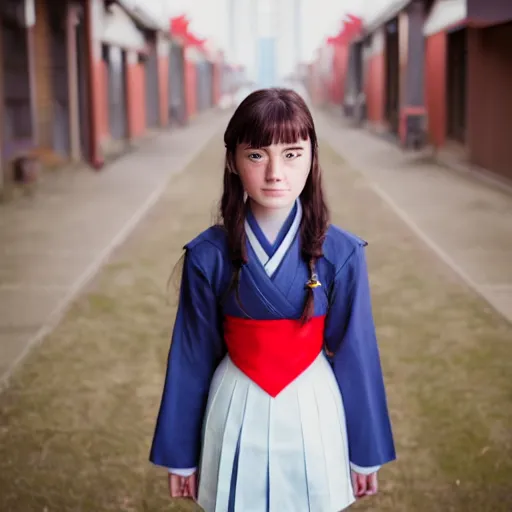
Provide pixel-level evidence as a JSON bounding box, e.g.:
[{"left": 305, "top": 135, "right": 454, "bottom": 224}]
[{"left": 235, "top": 139, "right": 311, "bottom": 209}]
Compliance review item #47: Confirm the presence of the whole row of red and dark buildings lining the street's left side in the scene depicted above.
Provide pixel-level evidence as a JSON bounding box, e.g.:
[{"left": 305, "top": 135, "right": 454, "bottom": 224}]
[{"left": 0, "top": 0, "right": 229, "bottom": 197}]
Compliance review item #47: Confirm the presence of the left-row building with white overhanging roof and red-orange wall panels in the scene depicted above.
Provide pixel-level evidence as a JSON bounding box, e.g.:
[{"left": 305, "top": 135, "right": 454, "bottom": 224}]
[{"left": 95, "top": 0, "right": 170, "bottom": 161}]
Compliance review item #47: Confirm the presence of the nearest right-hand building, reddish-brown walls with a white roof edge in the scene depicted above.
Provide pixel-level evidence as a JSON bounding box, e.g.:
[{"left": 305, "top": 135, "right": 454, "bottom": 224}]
[{"left": 423, "top": 0, "right": 512, "bottom": 180}]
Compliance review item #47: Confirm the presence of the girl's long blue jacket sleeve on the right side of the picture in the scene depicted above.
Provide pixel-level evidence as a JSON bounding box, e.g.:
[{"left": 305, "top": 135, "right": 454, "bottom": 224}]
[{"left": 325, "top": 243, "right": 396, "bottom": 472}]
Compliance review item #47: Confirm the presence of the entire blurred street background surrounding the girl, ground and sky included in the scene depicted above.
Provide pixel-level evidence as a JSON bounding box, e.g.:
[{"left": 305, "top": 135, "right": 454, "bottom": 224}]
[{"left": 0, "top": 0, "right": 512, "bottom": 512}]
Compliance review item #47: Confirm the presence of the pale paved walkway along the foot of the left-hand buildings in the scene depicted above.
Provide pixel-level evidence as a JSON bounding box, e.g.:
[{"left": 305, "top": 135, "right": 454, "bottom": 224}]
[{"left": 0, "top": 112, "right": 227, "bottom": 383}]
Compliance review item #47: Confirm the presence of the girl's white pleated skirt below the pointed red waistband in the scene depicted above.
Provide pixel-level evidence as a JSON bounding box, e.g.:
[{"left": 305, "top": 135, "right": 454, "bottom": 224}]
[{"left": 198, "top": 353, "right": 354, "bottom": 512}]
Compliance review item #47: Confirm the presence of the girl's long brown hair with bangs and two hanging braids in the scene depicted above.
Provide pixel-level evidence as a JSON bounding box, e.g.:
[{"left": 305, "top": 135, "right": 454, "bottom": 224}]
[{"left": 219, "top": 89, "right": 329, "bottom": 322}]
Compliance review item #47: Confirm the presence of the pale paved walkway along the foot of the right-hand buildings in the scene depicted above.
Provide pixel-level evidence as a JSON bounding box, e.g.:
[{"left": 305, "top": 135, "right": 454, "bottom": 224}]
[{"left": 315, "top": 111, "right": 512, "bottom": 322}]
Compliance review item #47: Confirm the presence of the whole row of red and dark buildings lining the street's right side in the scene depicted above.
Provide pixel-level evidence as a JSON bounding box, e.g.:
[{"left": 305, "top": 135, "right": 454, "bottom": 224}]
[{"left": 316, "top": 0, "right": 512, "bottom": 184}]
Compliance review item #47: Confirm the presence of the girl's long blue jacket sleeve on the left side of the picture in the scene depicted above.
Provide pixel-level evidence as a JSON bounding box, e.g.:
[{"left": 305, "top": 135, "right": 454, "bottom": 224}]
[{"left": 150, "top": 250, "right": 226, "bottom": 468}]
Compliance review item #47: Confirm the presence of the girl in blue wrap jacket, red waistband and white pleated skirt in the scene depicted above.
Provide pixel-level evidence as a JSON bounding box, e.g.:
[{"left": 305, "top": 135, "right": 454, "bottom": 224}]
[{"left": 150, "top": 89, "right": 395, "bottom": 512}]
